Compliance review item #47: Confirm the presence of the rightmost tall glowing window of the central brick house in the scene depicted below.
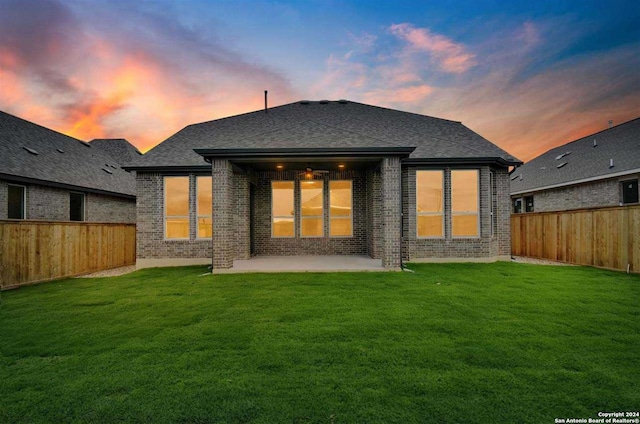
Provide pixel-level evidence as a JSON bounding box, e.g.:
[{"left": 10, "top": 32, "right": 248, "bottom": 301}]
[{"left": 451, "top": 170, "right": 478, "bottom": 237}]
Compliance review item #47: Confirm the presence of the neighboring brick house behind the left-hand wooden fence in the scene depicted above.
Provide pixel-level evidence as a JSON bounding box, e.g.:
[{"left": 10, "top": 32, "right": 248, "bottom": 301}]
[{"left": 0, "top": 112, "right": 136, "bottom": 222}]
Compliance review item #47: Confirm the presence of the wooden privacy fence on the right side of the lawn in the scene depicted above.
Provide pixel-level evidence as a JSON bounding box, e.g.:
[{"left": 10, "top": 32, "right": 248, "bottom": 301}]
[{"left": 511, "top": 206, "right": 640, "bottom": 272}]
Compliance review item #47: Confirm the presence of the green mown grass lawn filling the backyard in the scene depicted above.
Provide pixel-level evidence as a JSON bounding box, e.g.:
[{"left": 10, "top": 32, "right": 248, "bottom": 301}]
[{"left": 0, "top": 263, "right": 640, "bottom": 423}]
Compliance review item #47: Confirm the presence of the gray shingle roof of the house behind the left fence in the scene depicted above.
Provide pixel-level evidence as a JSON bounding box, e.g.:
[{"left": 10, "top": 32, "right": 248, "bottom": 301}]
[{"left": 0, "top": 111, "right": 135, "bottom": 197}]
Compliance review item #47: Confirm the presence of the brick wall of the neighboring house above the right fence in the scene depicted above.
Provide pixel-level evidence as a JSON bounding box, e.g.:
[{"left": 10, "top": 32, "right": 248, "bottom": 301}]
[{"left": 511, "top": 174, "right": 638, "bottom": 212}]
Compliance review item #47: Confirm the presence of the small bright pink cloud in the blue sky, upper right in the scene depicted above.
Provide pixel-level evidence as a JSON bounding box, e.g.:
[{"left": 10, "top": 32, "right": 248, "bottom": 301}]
[{"left": 389, "top": 23, "right": 476, "bottom": 74}]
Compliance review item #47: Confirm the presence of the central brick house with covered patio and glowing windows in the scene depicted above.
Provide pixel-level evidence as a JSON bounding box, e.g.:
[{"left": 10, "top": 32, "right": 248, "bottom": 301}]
[{"left": 125, "top": 100, "right": 521, "bottom": 269}]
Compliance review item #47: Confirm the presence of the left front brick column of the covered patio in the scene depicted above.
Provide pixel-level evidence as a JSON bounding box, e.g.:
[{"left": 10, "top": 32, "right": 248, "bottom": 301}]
[{"left": 211, "top": 159, "right": 235, "bottom": 269}]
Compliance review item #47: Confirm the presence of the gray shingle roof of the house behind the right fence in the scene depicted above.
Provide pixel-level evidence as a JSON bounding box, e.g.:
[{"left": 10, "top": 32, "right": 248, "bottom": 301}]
[{"left": 511, "top": 118, "right": 640, "bottom": 194}]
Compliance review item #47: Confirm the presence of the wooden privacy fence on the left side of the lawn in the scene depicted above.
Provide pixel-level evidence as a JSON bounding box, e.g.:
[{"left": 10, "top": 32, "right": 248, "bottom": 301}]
[{"left": 0, "top": 221, "right": 136, "bottom": 289}]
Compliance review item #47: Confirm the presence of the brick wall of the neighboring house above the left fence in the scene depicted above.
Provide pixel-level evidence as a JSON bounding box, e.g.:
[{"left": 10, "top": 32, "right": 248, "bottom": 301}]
[{"left": 0, "top": 180, "right": 136, "bottom": 223}]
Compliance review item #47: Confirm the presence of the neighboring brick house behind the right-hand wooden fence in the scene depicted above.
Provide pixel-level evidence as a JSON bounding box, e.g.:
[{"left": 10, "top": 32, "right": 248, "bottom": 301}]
[{"left": 511, "top": 118, "right": 640, "bottom": 213}]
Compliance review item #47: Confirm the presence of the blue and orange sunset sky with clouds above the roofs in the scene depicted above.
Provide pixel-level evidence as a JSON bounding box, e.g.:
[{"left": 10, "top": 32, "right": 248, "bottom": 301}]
[{"left": 0, "top": 0, "right": 640, "bottom": 161}]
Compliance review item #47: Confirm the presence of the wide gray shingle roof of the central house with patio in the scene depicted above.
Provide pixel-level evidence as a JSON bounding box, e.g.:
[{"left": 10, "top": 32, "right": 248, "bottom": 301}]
[{"left": 129, "top": 100, "right": 521, "bottom": 169}]
